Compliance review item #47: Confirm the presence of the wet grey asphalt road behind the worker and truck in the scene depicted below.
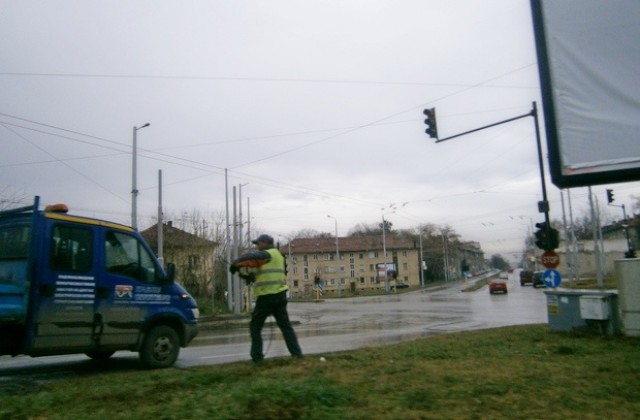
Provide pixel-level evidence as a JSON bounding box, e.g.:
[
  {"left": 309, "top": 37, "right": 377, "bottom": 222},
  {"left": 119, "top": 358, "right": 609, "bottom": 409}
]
[{"left": 0, "top": 274, "right": 547, "bottom": 383}]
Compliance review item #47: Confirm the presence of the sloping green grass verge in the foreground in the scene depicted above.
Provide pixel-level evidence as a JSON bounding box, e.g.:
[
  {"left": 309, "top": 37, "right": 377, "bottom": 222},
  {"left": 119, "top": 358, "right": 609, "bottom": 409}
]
[{"left": 0, "top": 325, "right": 640, "bottom": 420}]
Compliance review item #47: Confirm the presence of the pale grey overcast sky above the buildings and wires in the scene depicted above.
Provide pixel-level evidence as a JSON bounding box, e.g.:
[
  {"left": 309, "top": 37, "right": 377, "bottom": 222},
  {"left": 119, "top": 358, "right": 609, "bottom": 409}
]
[{"left": 0, "top": 0, "right": 640, "bottom": 258}]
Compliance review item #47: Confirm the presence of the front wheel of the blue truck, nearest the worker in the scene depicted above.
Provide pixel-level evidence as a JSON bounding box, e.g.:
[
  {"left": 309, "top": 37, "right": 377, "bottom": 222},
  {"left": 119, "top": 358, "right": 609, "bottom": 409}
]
[{"left": 140, "top": 325, "right": 180, "bottom": 368}]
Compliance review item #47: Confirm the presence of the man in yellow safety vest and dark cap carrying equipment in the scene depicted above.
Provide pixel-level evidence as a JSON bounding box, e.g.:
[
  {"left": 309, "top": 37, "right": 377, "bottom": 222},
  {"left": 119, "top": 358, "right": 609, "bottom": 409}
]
[{"left": 229, "top": 234, "right": 302, "bottom": 362}]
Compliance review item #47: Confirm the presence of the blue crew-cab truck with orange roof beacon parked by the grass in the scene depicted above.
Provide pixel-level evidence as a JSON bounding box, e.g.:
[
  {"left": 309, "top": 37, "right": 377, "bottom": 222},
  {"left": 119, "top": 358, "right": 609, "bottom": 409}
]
[{"left": 0, "top": 197, "right": 199, "bottom": 368}]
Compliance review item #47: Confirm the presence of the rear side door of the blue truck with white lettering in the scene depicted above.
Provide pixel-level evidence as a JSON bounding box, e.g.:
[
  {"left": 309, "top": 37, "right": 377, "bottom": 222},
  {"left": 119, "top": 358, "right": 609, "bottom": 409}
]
[{"left": 30, "top": 219, "right": 97, "bottom": 354}]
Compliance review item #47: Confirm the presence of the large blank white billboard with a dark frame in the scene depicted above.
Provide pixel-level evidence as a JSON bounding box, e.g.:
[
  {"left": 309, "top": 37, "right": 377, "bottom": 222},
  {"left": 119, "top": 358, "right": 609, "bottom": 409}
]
[{"left": 531, "top": 0, "right": 640, "bottom": 188}]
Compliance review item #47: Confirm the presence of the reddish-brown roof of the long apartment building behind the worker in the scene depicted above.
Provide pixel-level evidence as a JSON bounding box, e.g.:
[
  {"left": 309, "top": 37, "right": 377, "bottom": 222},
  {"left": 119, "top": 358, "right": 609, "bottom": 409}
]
[{"left": 280, "top": 235, "right": 419, "bottom": 254}]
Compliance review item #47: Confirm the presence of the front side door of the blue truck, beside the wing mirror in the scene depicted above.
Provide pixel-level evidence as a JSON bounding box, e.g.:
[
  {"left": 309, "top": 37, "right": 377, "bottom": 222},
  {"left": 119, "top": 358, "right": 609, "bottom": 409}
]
[{"left": 96, "top": 229, "right": 162, "bottom": 346}]
